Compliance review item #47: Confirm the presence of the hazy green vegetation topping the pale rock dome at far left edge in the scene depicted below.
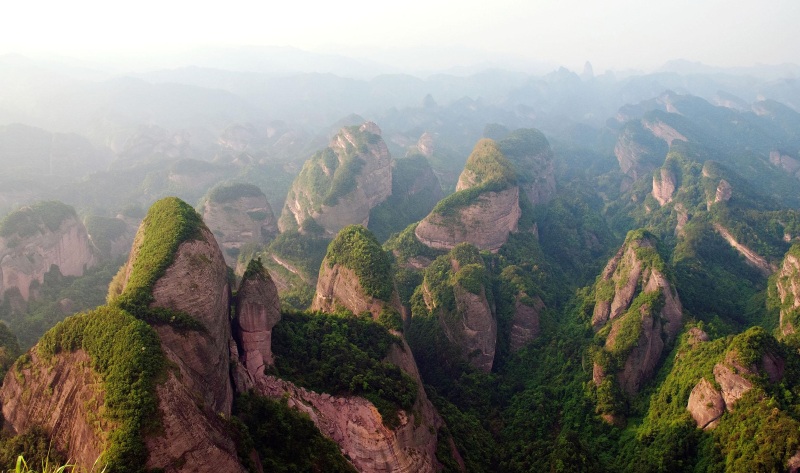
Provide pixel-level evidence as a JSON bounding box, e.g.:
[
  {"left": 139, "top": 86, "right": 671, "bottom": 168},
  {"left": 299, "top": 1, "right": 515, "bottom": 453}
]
[{"left": 0, "top": 200, "right": 77, "bottom": 238}]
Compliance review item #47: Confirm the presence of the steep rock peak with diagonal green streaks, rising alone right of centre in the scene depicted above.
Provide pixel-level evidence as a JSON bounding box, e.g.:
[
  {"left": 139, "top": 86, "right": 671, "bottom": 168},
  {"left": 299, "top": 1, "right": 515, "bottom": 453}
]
[{"left": 592, "top": 231, "right": 682, "bottom": 396}]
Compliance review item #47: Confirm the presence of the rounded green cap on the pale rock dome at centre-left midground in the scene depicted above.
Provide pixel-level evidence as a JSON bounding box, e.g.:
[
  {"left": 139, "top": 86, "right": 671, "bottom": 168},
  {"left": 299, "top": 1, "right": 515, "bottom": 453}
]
[{"left": 325, "top": 225, "right": 394, "bottom": 302}]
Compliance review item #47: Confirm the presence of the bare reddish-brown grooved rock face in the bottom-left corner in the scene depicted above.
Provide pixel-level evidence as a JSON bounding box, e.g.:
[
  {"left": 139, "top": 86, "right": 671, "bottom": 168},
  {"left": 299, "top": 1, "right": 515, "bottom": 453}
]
[{"left": 0, "top": 350, "right": 106, "bottom": 466}]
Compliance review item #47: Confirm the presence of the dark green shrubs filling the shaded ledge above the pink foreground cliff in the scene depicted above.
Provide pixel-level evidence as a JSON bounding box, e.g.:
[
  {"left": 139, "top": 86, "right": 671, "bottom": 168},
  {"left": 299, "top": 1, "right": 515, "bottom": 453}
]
[{"left": 271, "top": 313, "right": 417, "bottom": 427}]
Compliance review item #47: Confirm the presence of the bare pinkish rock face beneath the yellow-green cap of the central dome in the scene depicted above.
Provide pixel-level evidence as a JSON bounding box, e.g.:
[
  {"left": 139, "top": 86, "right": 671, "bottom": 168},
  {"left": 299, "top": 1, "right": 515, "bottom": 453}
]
[{"left": 414, "top": 186, "right": 522, "bottom": 251}]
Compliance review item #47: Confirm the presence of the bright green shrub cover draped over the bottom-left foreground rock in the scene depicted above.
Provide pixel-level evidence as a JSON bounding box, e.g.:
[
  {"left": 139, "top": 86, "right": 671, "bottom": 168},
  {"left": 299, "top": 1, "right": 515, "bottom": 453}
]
[{"left": 37, "top": 306, "right": 164, "bottom": 472}]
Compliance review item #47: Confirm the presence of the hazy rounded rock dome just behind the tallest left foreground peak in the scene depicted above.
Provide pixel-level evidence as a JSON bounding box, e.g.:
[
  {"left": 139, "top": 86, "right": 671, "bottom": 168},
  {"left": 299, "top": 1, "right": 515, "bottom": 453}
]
[{"left": 203, "top": 184, "right": 278, "bottom": 266}]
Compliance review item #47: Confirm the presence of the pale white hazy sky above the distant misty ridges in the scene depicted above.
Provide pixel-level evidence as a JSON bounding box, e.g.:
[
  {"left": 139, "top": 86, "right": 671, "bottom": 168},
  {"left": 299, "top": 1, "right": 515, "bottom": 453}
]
[{"left": 0, "top": 0, "right": 800, "bottom": 72}]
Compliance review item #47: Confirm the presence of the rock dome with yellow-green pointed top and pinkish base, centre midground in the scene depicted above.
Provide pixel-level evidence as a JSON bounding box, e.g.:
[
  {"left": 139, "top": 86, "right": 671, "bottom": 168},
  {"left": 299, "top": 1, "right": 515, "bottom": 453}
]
[{"left": 415, "top": 139, "right": 522, "bottom": 251}]
